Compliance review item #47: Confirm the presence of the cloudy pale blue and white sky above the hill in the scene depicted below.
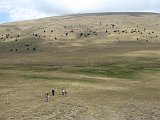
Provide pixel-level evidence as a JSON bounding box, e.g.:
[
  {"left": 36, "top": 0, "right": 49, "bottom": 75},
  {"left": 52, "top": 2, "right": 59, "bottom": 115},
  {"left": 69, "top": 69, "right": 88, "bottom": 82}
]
[{"left": 0, "top": 0, "right": 160, "bottom": 23}]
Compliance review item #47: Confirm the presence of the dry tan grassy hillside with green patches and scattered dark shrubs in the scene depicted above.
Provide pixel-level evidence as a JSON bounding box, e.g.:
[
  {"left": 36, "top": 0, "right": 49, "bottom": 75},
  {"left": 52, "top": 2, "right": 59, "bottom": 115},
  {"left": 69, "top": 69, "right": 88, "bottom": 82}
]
[{"left": 0, "top": 13, "right": 160, "bottom": 120}]
